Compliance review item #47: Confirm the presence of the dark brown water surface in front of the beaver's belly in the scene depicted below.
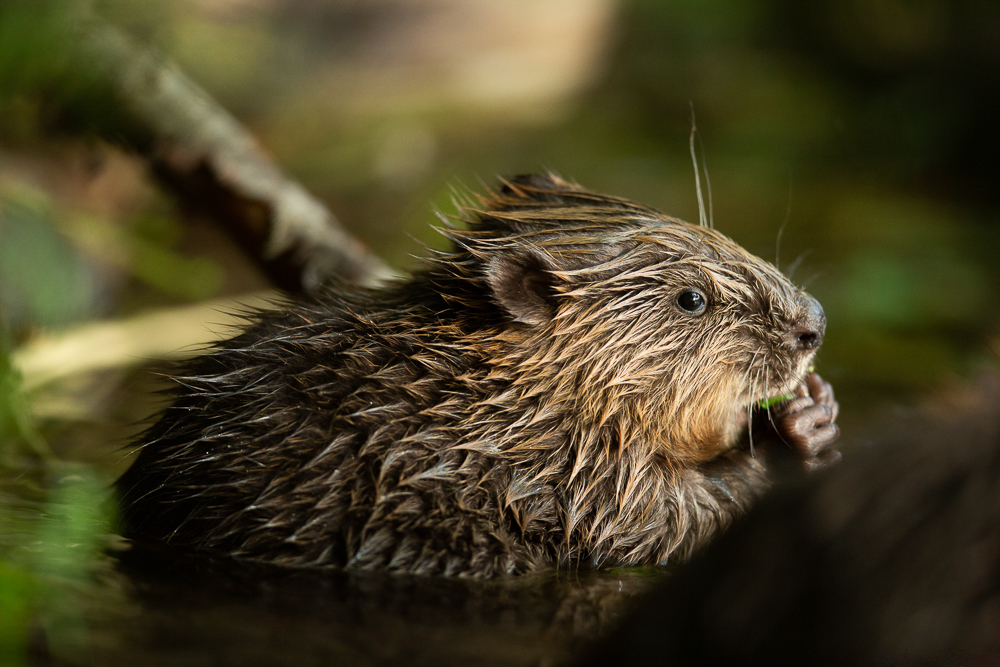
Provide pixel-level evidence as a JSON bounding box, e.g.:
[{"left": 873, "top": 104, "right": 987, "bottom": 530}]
[{"left": 30, "top": 548, "right": 665, "bottom": 666}]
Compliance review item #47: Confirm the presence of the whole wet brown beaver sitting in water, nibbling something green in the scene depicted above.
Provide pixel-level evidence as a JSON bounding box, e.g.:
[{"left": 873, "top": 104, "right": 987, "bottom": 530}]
[{"left": 118, "top": 175, "right": 839, "bottom": 576}]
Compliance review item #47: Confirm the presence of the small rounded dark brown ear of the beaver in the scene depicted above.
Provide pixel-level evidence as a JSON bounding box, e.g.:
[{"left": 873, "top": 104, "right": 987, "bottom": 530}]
[{"left": 486, "top": 250, "right": 556, "bottom": 326}]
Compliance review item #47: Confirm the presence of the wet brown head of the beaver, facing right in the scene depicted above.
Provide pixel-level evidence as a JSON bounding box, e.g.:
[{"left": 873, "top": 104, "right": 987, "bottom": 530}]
[{"left": 446, "top": 175, "right": 826, "bottom": 464}]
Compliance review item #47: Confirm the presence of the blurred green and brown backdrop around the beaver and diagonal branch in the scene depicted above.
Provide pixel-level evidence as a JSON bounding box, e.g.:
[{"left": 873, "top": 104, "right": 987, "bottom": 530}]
[{"left": 0, "top": 0, "right": 1000, "bottom": 664}]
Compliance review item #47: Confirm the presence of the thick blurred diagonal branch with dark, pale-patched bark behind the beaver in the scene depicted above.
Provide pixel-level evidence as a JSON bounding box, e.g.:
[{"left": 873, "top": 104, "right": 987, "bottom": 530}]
[{"left": 67, "top": 15, "right": 391, "bottom": 291}]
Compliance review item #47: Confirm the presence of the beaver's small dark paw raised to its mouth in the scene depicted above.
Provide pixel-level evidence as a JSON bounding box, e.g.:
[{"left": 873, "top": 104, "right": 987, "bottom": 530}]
[{"left": 772, "top": 373, "right": 840, "bottom": 471}]
